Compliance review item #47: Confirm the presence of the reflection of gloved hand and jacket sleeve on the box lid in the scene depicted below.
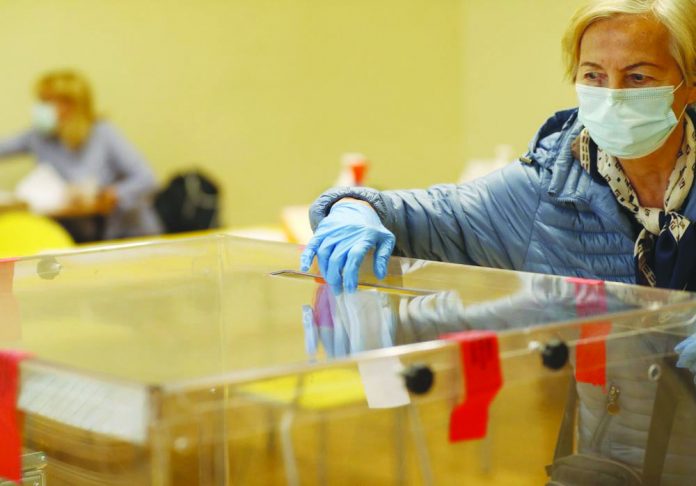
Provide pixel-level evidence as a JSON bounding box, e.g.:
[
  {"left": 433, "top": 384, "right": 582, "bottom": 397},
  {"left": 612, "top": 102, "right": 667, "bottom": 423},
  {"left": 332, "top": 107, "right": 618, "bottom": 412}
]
[{"left": 303, "top": 274, "right": 694, "bottom": 358}]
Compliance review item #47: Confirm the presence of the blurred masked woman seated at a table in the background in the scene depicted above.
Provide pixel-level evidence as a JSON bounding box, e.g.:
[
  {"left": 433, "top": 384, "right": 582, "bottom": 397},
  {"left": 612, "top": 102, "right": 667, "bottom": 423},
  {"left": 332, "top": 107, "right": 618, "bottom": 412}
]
[{"left": 0, "top": 71, "right": 160, "bottom": 242}]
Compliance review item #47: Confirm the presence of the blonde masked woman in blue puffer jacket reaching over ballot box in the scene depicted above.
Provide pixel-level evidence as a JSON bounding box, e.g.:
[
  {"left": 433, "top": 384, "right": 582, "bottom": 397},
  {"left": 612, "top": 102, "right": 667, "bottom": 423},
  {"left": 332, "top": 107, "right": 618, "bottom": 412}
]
[{"left": 301, "top": 0, "right": 696, "bottom": 484}]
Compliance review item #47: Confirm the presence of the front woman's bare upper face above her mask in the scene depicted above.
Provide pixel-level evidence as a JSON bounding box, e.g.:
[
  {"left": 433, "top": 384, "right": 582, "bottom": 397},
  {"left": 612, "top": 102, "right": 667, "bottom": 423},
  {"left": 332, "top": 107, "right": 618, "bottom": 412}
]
[{"left": 575, "top": 15, "right": 696, "bottom": 108}]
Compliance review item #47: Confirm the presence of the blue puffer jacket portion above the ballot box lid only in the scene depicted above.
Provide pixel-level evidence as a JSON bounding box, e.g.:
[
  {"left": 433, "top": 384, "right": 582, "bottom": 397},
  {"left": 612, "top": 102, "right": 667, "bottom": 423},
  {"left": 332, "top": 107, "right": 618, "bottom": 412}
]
[{"left": 310, "top": 109, "right": 696, "bottom": 283}]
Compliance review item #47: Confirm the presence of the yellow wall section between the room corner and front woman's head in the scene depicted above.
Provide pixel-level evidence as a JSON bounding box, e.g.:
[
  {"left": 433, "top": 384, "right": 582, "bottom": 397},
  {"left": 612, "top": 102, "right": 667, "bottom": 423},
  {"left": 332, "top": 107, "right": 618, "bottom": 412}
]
[{"left": 462, "top": 0, "right": 585, "bottom": 159}]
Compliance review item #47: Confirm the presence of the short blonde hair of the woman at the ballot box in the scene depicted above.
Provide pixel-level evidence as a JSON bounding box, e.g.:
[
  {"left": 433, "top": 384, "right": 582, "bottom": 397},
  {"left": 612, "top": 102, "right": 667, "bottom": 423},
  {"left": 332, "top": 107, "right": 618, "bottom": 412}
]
[{"left": 563, "top": 0, "right": 696, "bottom": 84}]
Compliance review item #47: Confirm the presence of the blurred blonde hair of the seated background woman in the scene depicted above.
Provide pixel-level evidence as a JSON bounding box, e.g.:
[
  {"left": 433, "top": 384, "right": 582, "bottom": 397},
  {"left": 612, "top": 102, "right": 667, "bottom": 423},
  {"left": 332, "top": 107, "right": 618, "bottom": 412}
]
[{"left": 36, "top": 69, "right": 97, "bottom": 149}]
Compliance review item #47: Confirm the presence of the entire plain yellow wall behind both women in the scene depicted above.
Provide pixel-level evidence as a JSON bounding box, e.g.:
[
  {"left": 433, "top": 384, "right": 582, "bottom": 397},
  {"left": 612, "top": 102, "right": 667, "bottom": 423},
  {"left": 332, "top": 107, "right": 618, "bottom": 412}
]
[{"left": 0, "top": 0, "right": 578, "bottom": 225}]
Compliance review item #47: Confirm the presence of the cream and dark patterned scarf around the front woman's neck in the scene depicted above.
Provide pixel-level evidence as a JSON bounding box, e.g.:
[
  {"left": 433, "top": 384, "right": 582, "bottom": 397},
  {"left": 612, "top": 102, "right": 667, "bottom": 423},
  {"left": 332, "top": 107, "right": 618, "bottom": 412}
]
[{"left": 575, "top": 116, "right": 696, "bottom": 290}]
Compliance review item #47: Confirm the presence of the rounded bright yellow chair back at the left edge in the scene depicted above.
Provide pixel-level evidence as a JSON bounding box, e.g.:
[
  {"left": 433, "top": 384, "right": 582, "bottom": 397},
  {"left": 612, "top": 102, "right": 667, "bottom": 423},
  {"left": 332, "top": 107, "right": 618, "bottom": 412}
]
[{"left": 0, "top": 211, "right": 75, "bottom": 258}]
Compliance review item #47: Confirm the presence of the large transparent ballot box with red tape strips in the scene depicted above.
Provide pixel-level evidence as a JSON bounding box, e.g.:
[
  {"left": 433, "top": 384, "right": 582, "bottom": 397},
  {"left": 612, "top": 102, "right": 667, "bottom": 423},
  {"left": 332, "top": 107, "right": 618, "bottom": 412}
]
[{"left": 0, "top": 235, "right": 696, "bottom": 486}]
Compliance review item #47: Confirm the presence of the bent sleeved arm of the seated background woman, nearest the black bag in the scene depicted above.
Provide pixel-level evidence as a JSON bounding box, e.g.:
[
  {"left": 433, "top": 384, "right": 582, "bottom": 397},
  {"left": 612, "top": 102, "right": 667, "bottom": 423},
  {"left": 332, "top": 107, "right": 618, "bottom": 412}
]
[{"left": 101, "top": 124, "right": 157, "bottom": 211}]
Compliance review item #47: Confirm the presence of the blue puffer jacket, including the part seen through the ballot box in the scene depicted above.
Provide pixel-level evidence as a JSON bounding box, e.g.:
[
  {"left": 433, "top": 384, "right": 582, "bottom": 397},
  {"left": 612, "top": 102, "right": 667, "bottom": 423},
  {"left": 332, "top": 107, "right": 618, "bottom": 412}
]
[{"left": 310, "top": 109, "right": 696, "bottom": 486}]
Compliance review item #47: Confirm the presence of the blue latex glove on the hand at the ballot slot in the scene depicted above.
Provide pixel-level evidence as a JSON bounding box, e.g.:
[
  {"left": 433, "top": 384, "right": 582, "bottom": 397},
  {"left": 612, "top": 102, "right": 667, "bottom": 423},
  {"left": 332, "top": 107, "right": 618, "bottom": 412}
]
[{"left": 300, "top": 202, "right": 396, "bottom": 295}]
